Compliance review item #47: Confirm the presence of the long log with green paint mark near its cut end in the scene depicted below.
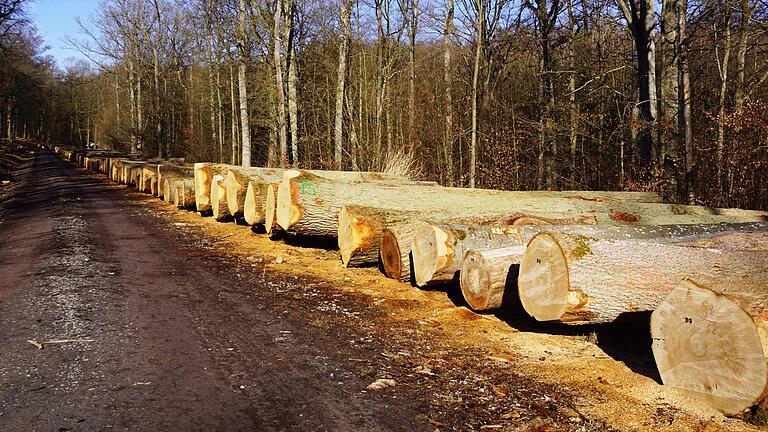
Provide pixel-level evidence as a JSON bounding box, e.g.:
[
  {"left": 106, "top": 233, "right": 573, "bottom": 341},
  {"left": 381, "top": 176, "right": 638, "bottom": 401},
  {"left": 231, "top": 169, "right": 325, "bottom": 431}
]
[{"left": 277, "top": 174, "right": 744, "bottom": 236}]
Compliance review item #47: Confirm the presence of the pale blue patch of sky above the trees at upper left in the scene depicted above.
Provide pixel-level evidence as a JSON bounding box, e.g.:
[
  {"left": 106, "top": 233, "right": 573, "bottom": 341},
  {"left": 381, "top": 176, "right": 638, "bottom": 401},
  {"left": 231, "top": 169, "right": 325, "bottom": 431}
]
[{"left": 27, "top": 0, "right": 99, "bottom": 68}]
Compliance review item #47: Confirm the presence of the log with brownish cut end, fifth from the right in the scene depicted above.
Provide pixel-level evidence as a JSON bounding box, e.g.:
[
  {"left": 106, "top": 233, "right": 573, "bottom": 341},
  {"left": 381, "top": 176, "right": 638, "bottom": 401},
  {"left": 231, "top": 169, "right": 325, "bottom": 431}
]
[{"left": 379, "top": 223, "right": 419, "bottom": 282}]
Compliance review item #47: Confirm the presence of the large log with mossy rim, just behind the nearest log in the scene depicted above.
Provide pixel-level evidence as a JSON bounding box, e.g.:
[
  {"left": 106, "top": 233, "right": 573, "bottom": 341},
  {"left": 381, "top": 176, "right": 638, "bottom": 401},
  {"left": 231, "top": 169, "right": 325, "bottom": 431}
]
[{"left": 518, "top": 232, "right": 768, "bottom": 323}]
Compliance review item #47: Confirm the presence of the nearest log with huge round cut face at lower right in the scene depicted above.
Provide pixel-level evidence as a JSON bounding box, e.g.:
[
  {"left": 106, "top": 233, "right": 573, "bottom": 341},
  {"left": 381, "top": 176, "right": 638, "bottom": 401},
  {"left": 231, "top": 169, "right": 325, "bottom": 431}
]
[{"left": 651, "top": 278, "right": 768, "bottom": 415}]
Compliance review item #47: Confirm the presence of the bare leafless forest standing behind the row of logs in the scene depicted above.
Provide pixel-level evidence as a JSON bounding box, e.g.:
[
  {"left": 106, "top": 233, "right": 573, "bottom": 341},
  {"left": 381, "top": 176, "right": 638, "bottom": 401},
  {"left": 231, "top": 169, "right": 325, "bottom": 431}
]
[{"left": 0, "top": 0, "right": 768, "bottom": 209}]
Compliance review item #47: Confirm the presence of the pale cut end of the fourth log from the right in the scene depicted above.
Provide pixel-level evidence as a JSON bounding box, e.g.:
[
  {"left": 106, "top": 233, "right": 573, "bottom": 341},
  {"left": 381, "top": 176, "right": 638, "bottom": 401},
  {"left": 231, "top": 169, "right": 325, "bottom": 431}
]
[{"left": 412, "top": 222, "right": 453, "bottom": 286}]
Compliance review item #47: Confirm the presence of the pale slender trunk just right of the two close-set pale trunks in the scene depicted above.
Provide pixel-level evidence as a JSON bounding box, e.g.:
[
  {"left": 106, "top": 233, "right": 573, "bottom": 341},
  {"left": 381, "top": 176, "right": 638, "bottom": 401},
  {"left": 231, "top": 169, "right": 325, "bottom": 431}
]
[{"left": 333, "top": 0, "right": 352, "bottom": 170}]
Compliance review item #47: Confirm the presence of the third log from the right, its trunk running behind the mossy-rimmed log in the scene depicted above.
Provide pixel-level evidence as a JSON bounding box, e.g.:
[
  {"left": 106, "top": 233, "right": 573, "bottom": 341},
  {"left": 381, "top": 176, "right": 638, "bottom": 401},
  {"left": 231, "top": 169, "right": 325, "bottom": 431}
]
[{"left": 459, "top": 223, "right": 768, "bottom": 310}]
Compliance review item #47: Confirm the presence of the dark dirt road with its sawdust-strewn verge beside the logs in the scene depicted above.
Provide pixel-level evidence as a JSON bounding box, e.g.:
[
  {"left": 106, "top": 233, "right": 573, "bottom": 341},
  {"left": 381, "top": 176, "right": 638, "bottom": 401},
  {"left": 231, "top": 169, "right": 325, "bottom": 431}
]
[{"left": 0, "top": 153, "right": 758, "bottom": 431}]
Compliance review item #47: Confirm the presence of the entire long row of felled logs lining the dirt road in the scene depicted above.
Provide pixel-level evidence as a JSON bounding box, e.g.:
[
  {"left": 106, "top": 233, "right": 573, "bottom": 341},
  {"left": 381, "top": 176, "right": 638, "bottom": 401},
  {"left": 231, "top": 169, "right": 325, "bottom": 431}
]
[{"left": 60, "top": 148, "right": 768, "bottom": 414}]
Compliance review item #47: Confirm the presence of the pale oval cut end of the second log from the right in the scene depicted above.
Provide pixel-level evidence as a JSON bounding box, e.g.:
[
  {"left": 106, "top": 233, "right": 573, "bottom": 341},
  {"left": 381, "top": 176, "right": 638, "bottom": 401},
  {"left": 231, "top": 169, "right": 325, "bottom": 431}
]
[{"left": 517, "top": 233, "right": 570, "bottom": 321}]
